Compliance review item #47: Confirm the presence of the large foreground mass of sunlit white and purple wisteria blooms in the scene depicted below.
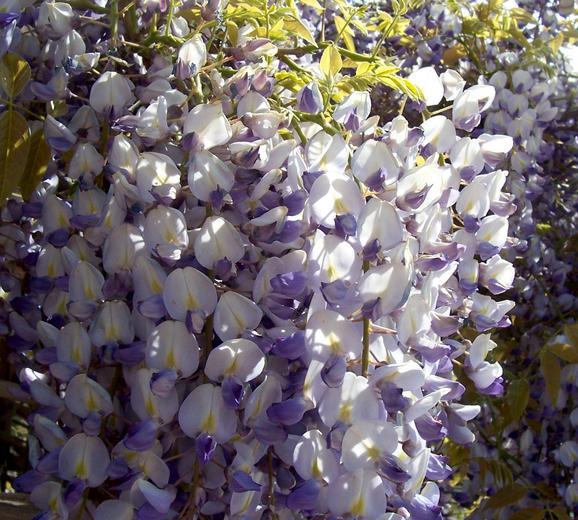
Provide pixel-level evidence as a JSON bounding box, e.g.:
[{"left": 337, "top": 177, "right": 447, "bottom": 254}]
[{"left": 0, "top": 0, "right": 516, "bottom": 520}]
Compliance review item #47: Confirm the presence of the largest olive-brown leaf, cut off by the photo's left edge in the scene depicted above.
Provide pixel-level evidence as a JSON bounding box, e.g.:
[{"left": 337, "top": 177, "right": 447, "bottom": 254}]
[{"left": 0, "top": 110, "right": 30, "bottom": 204}]
